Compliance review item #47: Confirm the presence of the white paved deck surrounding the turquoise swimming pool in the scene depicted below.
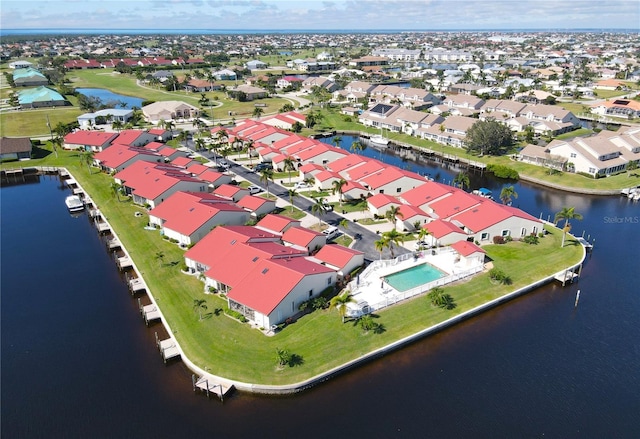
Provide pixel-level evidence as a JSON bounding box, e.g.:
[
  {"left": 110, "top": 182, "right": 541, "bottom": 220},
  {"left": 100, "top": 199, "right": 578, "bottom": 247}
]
[{"left": 349, "top": 247, "right": 484, "bottom": 315}]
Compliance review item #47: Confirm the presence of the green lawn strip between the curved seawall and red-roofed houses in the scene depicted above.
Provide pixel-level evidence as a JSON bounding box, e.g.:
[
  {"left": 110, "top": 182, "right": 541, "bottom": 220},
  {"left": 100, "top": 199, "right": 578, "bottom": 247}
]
[{"left": 2, "top": 151, "right": 582, "bottom": 385}]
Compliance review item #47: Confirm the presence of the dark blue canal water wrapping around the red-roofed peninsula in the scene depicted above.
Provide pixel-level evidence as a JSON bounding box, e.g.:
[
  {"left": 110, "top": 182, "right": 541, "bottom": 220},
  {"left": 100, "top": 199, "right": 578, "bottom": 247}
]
[{"left": 0, "top": 156, "right": 640, "bottom": 438}]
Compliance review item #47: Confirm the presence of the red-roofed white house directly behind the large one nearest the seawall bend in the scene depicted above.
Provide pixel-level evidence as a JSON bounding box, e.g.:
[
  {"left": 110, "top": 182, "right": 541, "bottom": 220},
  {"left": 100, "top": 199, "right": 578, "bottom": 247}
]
[{"left": 149, "top": 191, "right": 249, "bottom": 246}]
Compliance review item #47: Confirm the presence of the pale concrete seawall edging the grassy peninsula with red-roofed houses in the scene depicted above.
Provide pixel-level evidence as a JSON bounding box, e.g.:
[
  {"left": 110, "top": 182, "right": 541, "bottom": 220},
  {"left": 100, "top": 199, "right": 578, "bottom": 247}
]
[{"left": 46, "top": 168, "right": 586, "bottom": 395}]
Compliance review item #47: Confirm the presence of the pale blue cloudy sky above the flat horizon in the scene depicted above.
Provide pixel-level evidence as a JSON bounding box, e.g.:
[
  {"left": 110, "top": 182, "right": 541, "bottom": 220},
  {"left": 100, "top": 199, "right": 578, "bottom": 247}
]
[{"left": 0, "top": 0, "right": 640, "bottom": 31}]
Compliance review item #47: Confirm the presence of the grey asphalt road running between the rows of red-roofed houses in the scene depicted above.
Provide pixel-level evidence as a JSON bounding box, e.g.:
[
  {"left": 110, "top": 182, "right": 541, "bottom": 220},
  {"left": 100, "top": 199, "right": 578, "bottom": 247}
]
[{"left": 184, "top": 140, "right": 409, "bottom": 262}]
